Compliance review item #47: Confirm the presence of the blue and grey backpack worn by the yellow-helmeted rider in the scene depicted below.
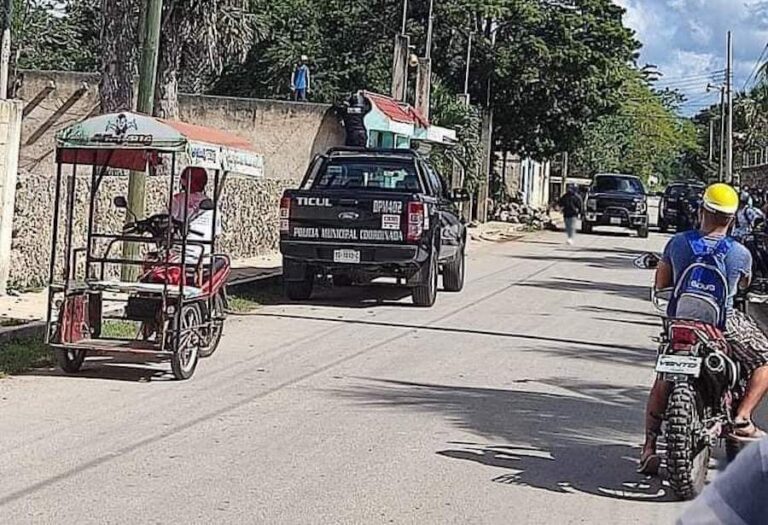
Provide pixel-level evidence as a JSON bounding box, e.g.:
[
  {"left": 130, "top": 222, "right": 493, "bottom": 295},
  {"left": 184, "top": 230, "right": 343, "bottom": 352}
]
[{"left": 667, "top": 231, "right": 735, "bottom": 330}]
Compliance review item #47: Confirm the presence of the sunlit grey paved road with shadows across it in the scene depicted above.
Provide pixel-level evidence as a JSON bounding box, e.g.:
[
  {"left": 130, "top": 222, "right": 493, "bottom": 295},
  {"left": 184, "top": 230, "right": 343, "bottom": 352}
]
[{"left": 0, "top": 229, "right": 756, "bottom": 525}]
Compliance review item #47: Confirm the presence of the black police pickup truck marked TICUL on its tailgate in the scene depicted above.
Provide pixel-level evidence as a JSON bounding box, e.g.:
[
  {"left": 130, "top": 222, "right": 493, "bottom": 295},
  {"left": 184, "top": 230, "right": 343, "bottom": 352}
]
[{"left": 280, "top": 148, "right": 467, "bottom": 306}]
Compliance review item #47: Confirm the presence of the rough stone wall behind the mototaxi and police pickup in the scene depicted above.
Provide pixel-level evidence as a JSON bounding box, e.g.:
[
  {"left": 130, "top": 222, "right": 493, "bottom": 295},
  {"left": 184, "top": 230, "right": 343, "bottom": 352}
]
[{"left": 9, "top": 72, "right": 344, "bottom": 288}]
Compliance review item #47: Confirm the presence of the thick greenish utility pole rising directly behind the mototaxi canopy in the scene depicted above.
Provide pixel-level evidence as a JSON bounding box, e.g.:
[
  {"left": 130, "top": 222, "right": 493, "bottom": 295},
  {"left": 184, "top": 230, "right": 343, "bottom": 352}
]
[{"left": 122, "top": 0, "right": 163, "bottom": 281}]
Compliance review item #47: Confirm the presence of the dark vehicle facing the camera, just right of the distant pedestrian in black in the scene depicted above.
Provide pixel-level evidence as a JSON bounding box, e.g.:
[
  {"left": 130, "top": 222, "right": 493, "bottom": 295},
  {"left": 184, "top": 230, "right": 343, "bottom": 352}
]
[{"left": 582, "top": 173, "right": 648, "bottom": 238}]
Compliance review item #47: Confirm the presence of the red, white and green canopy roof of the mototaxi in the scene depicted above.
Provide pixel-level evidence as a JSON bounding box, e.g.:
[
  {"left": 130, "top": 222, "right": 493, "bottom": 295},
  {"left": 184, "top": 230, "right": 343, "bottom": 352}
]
[{"left": 56, "top": 112, "right": 264, "bottom": 177}]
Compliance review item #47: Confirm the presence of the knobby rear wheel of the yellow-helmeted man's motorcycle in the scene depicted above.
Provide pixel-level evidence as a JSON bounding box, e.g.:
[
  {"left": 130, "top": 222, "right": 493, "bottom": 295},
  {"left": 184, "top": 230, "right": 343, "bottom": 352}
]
[{"left": 665, "top": 383, "right": 712, "bottom": 500}]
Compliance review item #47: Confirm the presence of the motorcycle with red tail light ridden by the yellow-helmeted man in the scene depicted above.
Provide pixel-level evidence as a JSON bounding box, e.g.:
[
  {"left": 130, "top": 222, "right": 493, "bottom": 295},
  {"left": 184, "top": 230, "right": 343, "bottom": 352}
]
[{"left": 636, "top": 254, "right": 747, "bottom": 500}]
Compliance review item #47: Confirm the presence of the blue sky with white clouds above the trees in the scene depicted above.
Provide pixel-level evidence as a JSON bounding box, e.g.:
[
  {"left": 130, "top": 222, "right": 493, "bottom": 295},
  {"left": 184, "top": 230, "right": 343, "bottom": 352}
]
[{"left": 614, "top": 0, "right": 768, "bottom": 113}]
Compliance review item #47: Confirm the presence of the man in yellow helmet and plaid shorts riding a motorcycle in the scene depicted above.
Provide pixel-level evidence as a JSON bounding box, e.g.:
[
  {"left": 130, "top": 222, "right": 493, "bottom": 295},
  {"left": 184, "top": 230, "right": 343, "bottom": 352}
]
[{"left": 638, "top": 184, "right": 768, "bottom": 474}]
